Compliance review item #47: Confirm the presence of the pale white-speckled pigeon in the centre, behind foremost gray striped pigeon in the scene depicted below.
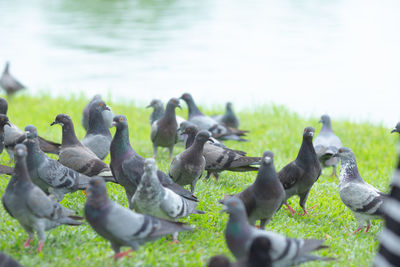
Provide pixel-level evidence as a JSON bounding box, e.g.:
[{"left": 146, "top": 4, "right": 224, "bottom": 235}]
[{"left": 131, "top": 159, "right": 204, "bottom": 242}]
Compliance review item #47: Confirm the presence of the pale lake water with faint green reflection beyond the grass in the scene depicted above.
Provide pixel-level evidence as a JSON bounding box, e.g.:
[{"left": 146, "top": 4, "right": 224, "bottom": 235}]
[{"left": 0, "top": 0, "right": 400, "bottom": 126}]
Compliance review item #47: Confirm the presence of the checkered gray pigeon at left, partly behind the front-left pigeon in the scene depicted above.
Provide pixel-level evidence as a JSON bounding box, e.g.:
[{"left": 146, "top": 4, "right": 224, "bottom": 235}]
[{"left": 24, "top": 125, "right": 90, "bottom": 201}]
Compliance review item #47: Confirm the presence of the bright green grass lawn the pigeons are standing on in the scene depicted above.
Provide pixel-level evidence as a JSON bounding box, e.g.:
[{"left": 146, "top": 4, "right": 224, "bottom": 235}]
[{"left": 0, "top": 95, "right": 397, "bottom": 266}]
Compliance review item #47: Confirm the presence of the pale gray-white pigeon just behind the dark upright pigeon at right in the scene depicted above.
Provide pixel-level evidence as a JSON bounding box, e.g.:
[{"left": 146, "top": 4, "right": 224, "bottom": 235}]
[{"left": 314, "top": 115, "right": 342, "bottom": 177}]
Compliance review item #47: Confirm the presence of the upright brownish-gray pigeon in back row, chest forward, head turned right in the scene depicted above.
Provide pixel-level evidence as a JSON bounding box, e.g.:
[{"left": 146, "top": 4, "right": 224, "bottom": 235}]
[{"left": 150, "top": 98, "right": 181, "bottom": 159}]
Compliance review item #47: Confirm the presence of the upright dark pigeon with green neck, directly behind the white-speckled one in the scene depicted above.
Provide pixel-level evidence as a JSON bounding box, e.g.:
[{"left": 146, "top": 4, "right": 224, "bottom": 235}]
[{"left": 110, "top": 115, "right": 198, "bottom": 208}]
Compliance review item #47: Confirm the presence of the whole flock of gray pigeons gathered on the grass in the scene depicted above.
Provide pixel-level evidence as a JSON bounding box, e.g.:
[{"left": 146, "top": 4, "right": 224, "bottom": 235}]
[{"left": 0, "top": 63, "right": 400, "bottom": 267}]
